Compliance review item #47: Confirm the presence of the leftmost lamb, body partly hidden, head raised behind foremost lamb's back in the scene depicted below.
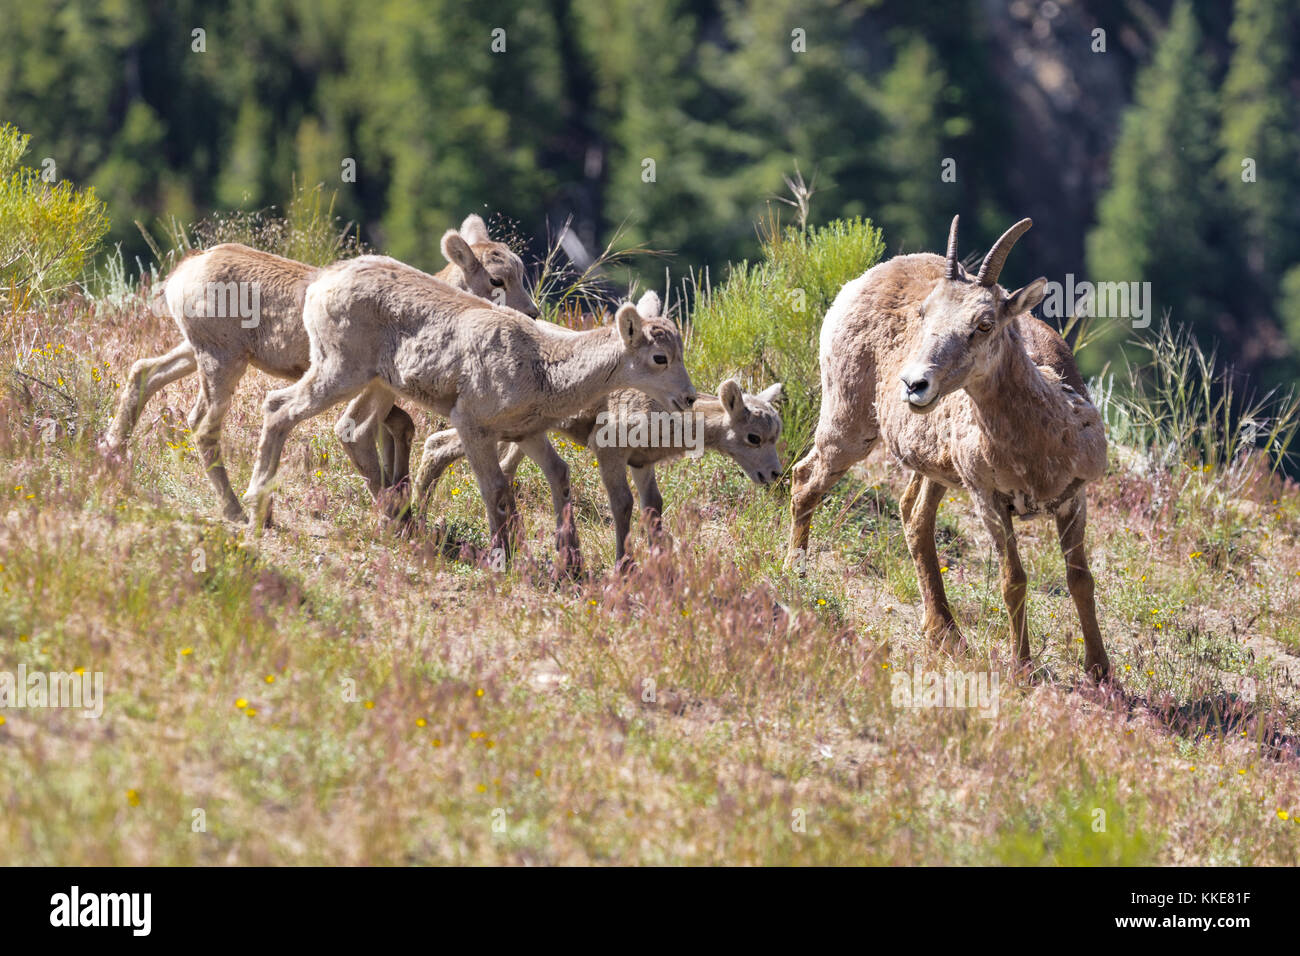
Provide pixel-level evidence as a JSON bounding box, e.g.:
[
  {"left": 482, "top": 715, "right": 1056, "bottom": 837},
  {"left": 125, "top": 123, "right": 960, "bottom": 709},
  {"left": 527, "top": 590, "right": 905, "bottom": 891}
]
[{"left": 104, "top": 216, "right": 537, "bottom": 520}]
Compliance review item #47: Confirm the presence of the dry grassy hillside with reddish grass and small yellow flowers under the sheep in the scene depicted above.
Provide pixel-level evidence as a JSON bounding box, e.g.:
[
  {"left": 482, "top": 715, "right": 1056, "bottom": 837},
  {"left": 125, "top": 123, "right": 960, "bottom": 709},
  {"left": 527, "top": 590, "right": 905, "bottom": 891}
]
[{"left": 0, "top": 235, "right": 1300, "bottom": 865}]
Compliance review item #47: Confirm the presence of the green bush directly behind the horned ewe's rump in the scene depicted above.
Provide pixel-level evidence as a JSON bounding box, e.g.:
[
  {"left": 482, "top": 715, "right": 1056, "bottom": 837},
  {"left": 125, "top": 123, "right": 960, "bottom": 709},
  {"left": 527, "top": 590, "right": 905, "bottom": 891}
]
[{"left": 686, "top": 219, "right": 885, "bottom": 466}]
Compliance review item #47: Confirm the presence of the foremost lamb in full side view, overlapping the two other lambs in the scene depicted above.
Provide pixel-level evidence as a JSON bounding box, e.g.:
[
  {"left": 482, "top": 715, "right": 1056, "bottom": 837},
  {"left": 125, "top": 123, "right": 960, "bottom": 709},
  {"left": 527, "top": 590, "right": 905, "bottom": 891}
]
[{"left": 244, "top": 256, "right": 696, "bottom": 567}]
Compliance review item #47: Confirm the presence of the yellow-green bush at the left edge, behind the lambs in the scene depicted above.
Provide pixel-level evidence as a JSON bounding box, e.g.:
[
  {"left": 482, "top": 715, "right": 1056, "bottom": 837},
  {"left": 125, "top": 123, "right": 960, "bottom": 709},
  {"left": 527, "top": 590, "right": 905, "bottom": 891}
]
[{"left": 0, "top": 124, "right": 108, "bottom": 315}]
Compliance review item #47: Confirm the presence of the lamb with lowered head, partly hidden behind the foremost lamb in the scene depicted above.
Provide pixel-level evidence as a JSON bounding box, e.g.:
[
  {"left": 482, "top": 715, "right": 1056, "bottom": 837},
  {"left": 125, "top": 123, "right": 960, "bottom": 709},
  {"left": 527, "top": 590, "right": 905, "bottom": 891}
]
[{"left": 413, "top": 291, "right": 781, "bottom": 562}]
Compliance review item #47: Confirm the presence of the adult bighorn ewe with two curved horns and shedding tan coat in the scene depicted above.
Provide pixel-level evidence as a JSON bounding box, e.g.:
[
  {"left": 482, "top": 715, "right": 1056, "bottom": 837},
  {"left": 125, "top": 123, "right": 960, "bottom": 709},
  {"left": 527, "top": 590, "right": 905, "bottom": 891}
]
[{"left": 787, "top": 217, "right": 1110, "bottom": 679}]
